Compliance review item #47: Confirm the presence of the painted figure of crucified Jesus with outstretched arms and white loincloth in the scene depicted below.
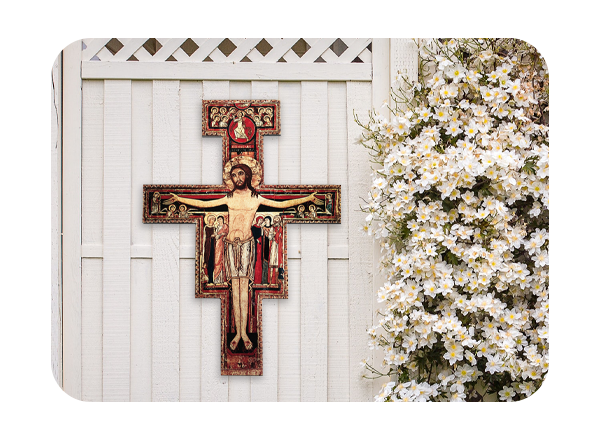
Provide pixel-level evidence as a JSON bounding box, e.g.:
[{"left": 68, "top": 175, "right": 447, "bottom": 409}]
[{"left": 165, "top": 163, "right": 322, "bottom": 351}]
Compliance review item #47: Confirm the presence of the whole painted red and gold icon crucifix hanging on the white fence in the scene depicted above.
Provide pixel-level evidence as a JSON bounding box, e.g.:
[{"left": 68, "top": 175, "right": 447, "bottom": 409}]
[{"left": 143, "top": 100, "right": 341, "bottom": 376}]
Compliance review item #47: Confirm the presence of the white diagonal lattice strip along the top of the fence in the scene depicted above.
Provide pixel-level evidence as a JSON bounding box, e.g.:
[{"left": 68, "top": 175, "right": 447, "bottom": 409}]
[{"left": 82, "top": 38, "right": 372, "bottom": 64}]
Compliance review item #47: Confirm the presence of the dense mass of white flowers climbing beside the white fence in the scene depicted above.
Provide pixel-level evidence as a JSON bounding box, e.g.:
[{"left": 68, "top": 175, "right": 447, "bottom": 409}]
[{"left": 357, "top": 38, "right": 550, "bottom": 401}]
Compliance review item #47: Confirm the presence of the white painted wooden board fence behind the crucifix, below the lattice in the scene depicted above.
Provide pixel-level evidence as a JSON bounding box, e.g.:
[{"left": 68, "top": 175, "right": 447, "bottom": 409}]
[{"left": 58, "top": 39, "right": 420, "bottom": 401}]
